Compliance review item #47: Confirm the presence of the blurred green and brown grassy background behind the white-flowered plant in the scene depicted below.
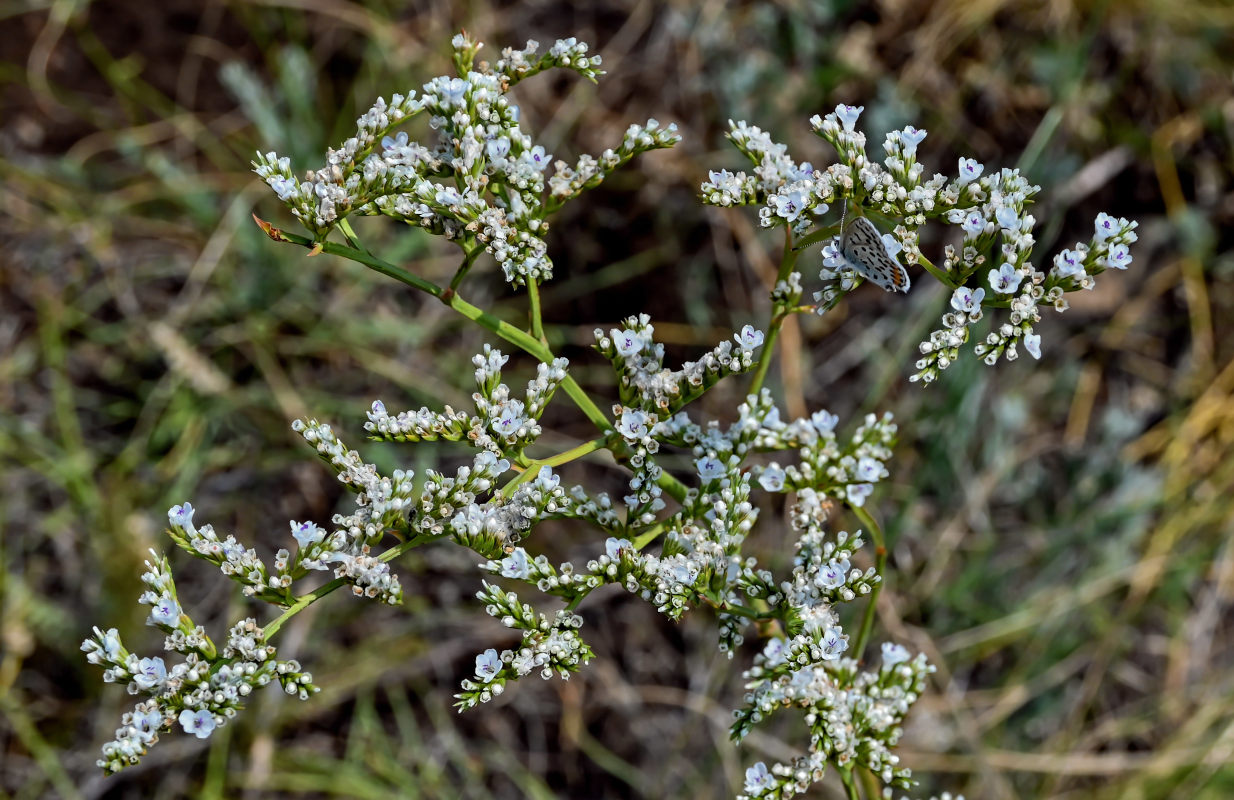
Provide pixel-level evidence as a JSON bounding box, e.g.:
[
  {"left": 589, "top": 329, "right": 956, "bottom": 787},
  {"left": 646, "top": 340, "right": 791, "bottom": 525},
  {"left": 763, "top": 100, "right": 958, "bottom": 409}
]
[{"left": 0, "top": 0, "right": 1234, "bottom": 800}]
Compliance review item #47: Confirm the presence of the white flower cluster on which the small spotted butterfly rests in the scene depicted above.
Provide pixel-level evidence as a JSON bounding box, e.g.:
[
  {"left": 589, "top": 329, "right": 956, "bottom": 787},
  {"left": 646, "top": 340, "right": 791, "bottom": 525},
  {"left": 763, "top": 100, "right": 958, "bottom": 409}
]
[{"left": 701, "top": 105, "right": 1137, "bottom": 383}]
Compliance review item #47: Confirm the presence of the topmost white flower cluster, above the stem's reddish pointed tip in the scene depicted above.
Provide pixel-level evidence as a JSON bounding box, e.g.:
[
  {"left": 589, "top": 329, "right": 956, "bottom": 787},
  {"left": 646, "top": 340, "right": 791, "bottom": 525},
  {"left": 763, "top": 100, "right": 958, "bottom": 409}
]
[{"left": 253, "top": 35, "right": 681, "bottom": 284}]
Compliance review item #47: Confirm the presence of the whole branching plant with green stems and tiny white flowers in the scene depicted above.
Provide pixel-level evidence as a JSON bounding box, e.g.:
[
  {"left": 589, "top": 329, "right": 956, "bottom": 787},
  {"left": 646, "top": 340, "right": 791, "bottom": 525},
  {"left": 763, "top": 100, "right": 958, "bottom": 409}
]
[{"left": 83, "top": 35, "right": 1135, "bottom": 798}]
